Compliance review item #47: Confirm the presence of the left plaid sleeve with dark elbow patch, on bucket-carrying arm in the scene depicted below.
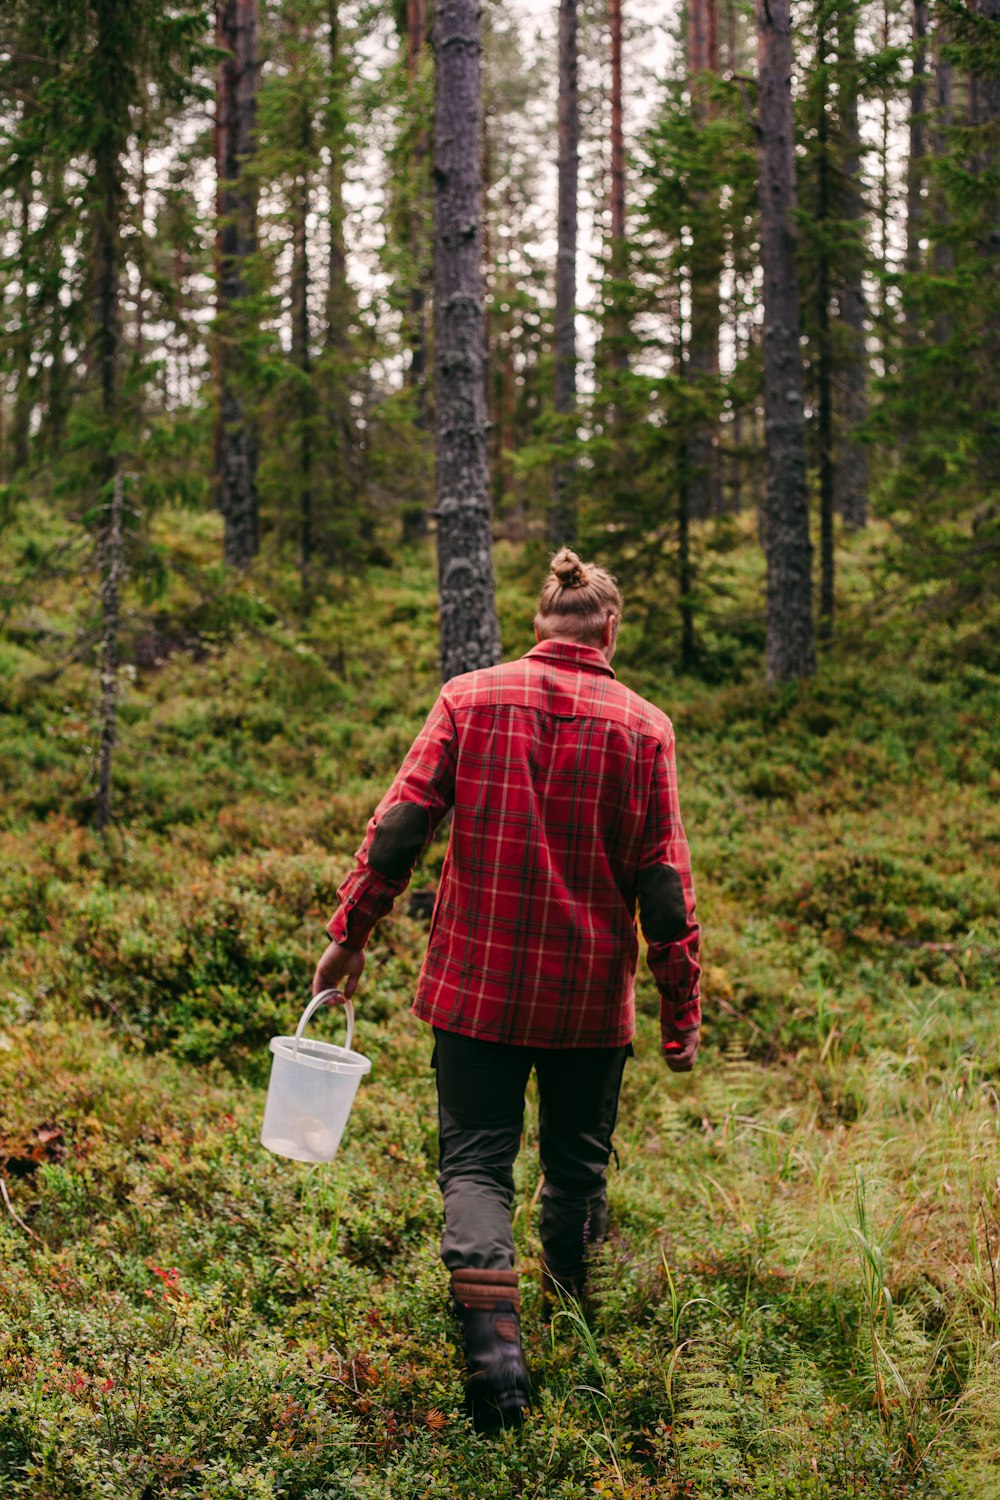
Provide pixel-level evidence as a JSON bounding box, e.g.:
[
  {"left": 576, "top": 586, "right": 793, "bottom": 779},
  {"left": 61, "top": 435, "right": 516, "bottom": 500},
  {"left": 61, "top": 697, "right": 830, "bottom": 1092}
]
[{"left": 327, "top": 692, "right": 457, "bottom": 950}]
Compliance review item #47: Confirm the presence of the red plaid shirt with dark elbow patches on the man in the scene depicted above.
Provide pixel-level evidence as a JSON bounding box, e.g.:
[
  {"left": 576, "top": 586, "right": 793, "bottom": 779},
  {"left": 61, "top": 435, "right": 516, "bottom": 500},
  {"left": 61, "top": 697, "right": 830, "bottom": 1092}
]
[{"left": 327, "top": 641, "right": 700, "bottom": 1047}]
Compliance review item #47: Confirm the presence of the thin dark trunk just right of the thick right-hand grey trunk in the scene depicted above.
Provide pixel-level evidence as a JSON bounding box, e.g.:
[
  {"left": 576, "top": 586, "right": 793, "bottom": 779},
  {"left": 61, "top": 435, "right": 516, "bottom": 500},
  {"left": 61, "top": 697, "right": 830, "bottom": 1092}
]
[{"left": 816, "top": 23, "right": 834, "bottom": 642}]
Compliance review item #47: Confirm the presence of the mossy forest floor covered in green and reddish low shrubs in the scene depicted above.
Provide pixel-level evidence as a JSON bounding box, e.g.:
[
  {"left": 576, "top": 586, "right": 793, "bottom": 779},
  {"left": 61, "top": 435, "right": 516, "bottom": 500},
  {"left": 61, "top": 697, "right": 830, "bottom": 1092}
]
[{"left": 0, "top": 515, "right": 1000, "bottom": 1500}]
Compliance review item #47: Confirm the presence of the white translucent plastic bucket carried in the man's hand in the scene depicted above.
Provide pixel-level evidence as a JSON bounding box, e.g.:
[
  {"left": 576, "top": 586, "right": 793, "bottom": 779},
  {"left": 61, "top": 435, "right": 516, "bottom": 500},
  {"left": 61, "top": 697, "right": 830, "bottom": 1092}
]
[{"left": 261, "top": 990, "right": 372, "bottom": 1161}]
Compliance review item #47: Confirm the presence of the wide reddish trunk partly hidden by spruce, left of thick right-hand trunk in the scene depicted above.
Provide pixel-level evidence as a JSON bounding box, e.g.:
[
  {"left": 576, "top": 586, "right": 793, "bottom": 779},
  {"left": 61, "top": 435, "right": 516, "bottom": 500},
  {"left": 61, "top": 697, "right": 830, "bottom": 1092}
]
[{"left": 687, "top": 0, "right": 723, "bottom": 519}]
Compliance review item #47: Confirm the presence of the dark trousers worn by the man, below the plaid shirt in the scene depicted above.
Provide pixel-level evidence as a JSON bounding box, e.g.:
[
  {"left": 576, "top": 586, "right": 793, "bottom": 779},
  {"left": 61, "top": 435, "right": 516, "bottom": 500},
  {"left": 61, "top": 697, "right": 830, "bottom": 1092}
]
[{"left": 433, "top": 1028, "right": 631, "bottom": 1278}]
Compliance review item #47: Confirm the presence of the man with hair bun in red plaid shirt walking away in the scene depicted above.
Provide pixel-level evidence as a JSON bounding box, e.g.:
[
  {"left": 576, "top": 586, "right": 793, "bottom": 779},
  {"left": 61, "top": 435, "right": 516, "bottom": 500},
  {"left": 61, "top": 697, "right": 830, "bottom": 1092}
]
[{"left": 313, "top": 548, "right": 700, "bottom": 1428}]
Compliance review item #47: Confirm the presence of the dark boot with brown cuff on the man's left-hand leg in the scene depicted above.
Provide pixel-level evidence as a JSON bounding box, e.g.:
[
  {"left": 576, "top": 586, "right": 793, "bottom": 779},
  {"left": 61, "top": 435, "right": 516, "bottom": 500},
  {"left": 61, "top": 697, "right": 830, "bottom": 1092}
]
[{"left": 451, "top": 1268, "right": 529, "bottom": 1433}]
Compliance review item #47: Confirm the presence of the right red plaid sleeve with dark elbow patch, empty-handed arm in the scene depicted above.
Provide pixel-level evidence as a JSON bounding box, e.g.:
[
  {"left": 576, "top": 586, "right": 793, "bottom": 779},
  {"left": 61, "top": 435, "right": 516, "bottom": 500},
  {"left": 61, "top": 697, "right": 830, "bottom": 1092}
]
[{"left": 636, "top": 731, "right": 702, "bottom": 1038}]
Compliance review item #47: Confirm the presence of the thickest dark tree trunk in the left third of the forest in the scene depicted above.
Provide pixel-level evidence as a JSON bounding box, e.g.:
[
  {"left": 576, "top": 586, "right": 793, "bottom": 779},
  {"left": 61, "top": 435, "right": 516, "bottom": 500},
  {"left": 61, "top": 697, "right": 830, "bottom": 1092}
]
[{"left": 214, "top": 0, "right": 259, "bottom": 569}]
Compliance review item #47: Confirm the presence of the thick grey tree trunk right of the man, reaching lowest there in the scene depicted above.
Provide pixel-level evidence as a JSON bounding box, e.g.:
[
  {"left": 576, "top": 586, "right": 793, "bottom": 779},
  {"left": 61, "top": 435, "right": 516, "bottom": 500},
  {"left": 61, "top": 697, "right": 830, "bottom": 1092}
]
[{"left": 757, "top": 0, "right": 816, "bottom": 683}]
